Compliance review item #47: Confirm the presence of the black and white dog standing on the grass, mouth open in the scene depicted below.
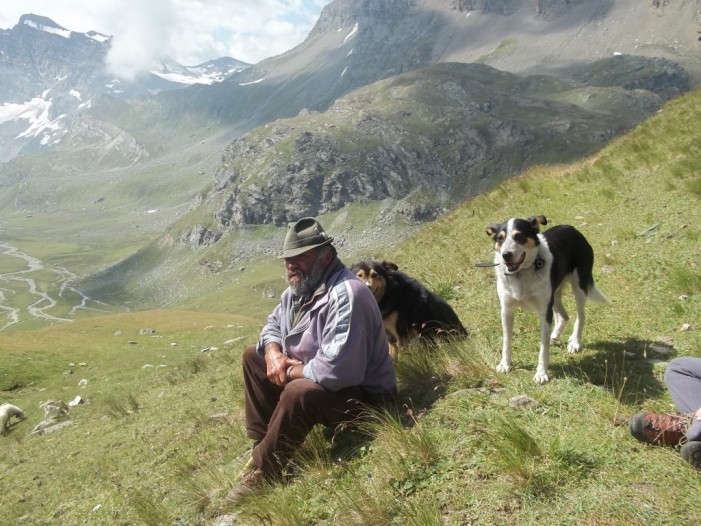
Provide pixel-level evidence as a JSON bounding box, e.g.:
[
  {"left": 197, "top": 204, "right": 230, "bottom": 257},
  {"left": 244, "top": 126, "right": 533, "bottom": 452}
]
[{"left": 487, "top": 216, "right": 608, "bottom": 384}]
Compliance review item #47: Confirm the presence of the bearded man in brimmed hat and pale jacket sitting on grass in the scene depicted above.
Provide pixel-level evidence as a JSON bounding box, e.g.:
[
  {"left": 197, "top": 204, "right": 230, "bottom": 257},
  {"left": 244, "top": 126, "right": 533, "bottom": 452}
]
[{"left": 227, "top": 217, "right": 396, "bottom": 503}]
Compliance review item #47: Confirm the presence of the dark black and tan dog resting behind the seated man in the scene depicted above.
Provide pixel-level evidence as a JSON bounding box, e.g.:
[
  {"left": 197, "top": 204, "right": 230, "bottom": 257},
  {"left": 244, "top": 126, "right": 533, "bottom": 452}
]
[{"left": 351, "top": 261, "right": 467, "bottom": 359}]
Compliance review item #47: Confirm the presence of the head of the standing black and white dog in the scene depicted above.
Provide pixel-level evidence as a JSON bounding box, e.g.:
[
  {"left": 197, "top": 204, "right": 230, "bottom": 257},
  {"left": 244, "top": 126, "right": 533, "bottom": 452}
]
[{"left": 487, "top": 215, "right": 548, "bottom": 274}]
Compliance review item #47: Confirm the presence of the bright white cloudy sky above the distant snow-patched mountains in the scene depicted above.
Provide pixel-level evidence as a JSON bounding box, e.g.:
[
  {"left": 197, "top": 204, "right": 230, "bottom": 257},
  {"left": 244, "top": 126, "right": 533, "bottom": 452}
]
[{"left": 0, "top": 0, "right": 331, "bottom": 78}]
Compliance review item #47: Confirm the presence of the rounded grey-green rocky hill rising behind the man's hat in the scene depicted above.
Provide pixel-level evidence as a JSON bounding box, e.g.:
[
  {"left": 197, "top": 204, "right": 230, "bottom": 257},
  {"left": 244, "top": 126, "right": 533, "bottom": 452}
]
[{"left": 204, "top": 60, "right": 662, "bottom": 229}]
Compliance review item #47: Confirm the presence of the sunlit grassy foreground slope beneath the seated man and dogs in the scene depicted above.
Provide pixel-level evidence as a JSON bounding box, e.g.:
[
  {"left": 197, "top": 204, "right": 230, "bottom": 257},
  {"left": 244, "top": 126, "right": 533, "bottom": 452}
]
[{"left": 0, "top": 91, "right": 701, "bottom": 526}]
